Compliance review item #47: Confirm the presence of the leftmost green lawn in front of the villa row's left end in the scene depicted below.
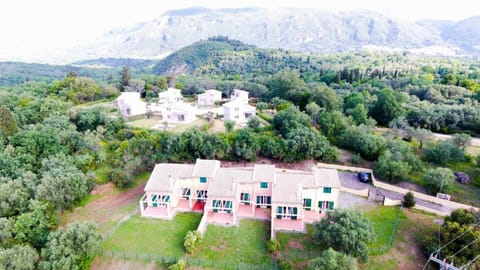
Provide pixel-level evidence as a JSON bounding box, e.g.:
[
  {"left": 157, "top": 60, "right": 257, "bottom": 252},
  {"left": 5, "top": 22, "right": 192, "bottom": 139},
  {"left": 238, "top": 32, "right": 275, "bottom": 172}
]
[{"left": 102, "top": 213, "right": 201, "bottom": 257}]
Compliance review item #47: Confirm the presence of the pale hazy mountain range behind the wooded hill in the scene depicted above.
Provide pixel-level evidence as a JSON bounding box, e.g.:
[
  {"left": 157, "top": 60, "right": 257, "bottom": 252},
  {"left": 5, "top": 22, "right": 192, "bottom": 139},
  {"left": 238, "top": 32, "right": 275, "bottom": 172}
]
[{"left": 69, "top": 7, "right": 480, "bottom": 59}]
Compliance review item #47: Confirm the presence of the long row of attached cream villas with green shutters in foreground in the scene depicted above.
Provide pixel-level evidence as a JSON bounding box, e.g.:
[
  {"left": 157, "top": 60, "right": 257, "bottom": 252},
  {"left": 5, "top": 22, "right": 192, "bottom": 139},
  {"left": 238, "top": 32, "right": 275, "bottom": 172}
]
[{"left": 139, "top": 159, "right": 340, "bottom": 237}]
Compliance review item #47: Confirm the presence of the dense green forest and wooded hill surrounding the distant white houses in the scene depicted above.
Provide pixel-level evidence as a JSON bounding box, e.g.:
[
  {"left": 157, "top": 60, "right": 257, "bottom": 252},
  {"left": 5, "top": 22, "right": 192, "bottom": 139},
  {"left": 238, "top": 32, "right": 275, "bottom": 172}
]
[{"left": 0, "top": 37, "right": 480, "bottom": 269}]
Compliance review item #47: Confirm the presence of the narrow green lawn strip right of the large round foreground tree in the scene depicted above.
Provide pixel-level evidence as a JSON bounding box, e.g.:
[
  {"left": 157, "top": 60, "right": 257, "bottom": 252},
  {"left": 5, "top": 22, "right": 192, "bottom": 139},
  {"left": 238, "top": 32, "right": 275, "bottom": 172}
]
[{"left": 365, "top": 206, "right": 406, "bottom": 254}]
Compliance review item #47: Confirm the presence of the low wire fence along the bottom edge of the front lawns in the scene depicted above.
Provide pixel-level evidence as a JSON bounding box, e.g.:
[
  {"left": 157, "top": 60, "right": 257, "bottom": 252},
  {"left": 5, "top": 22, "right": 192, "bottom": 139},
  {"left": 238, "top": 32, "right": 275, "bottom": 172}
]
[{"left": 98, "top": 250, "right": 277, "bottom": 270}]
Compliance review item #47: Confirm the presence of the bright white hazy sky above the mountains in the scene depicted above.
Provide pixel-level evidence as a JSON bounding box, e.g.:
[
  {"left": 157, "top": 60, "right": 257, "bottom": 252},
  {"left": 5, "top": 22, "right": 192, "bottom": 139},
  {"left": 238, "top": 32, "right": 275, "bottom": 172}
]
[{"left": 0, "top": 0, "right": 480, "bottom": 60}]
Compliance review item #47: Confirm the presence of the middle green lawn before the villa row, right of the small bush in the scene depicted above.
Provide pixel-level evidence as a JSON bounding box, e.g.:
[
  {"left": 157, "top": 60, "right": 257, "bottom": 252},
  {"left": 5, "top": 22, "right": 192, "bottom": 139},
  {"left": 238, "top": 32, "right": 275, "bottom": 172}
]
[{"left": 194, "top": 219, "right": 272, "bottom": 267}]
